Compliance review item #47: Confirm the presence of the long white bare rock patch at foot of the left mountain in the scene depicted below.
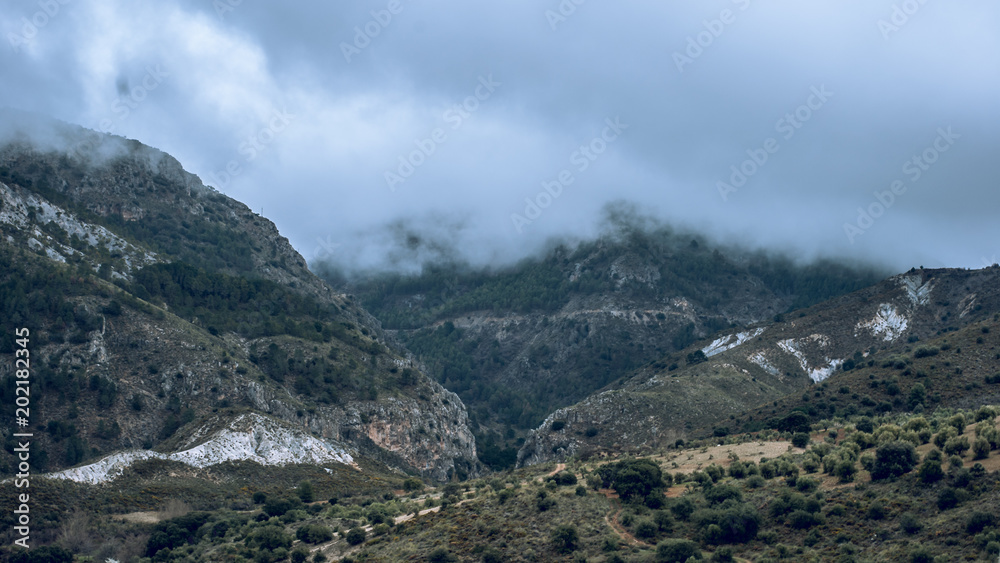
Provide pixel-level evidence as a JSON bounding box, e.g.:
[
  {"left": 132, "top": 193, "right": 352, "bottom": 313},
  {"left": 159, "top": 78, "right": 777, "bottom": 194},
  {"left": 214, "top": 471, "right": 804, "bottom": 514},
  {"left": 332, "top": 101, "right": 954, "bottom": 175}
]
[{"left": 47, "top": 414, "right": 354, "bottom": 485}]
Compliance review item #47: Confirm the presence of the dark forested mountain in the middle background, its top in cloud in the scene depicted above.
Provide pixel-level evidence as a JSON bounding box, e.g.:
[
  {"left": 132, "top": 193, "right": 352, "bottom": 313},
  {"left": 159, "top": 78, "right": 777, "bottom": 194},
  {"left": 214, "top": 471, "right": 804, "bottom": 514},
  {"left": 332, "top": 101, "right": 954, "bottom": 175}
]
[{"left": 318, "top": 223, "right": 884, "bottom": 468}]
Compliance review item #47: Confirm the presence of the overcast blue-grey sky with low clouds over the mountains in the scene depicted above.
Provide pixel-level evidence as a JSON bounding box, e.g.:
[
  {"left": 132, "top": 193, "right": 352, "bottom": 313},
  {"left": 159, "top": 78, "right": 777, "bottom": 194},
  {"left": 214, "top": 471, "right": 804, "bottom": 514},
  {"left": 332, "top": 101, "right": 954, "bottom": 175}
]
[{"left": 0, "top": 0, "right": 1000, "bottom": 270}]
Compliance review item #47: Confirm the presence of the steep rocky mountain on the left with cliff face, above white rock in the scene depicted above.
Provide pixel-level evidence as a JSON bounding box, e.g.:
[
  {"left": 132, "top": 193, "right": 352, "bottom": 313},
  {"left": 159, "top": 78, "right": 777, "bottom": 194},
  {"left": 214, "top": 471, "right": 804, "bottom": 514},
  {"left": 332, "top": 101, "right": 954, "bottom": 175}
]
[{"left": 0, "top": 112, "right": 479, "bottom": 480}]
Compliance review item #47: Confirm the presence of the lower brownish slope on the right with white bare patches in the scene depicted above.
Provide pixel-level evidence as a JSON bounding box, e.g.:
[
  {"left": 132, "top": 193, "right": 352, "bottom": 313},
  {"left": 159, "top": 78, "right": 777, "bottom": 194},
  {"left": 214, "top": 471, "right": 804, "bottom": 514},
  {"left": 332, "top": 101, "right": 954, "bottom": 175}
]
[{"left": 518, "top": 266, "right": 1000, "bottom": 465}]
